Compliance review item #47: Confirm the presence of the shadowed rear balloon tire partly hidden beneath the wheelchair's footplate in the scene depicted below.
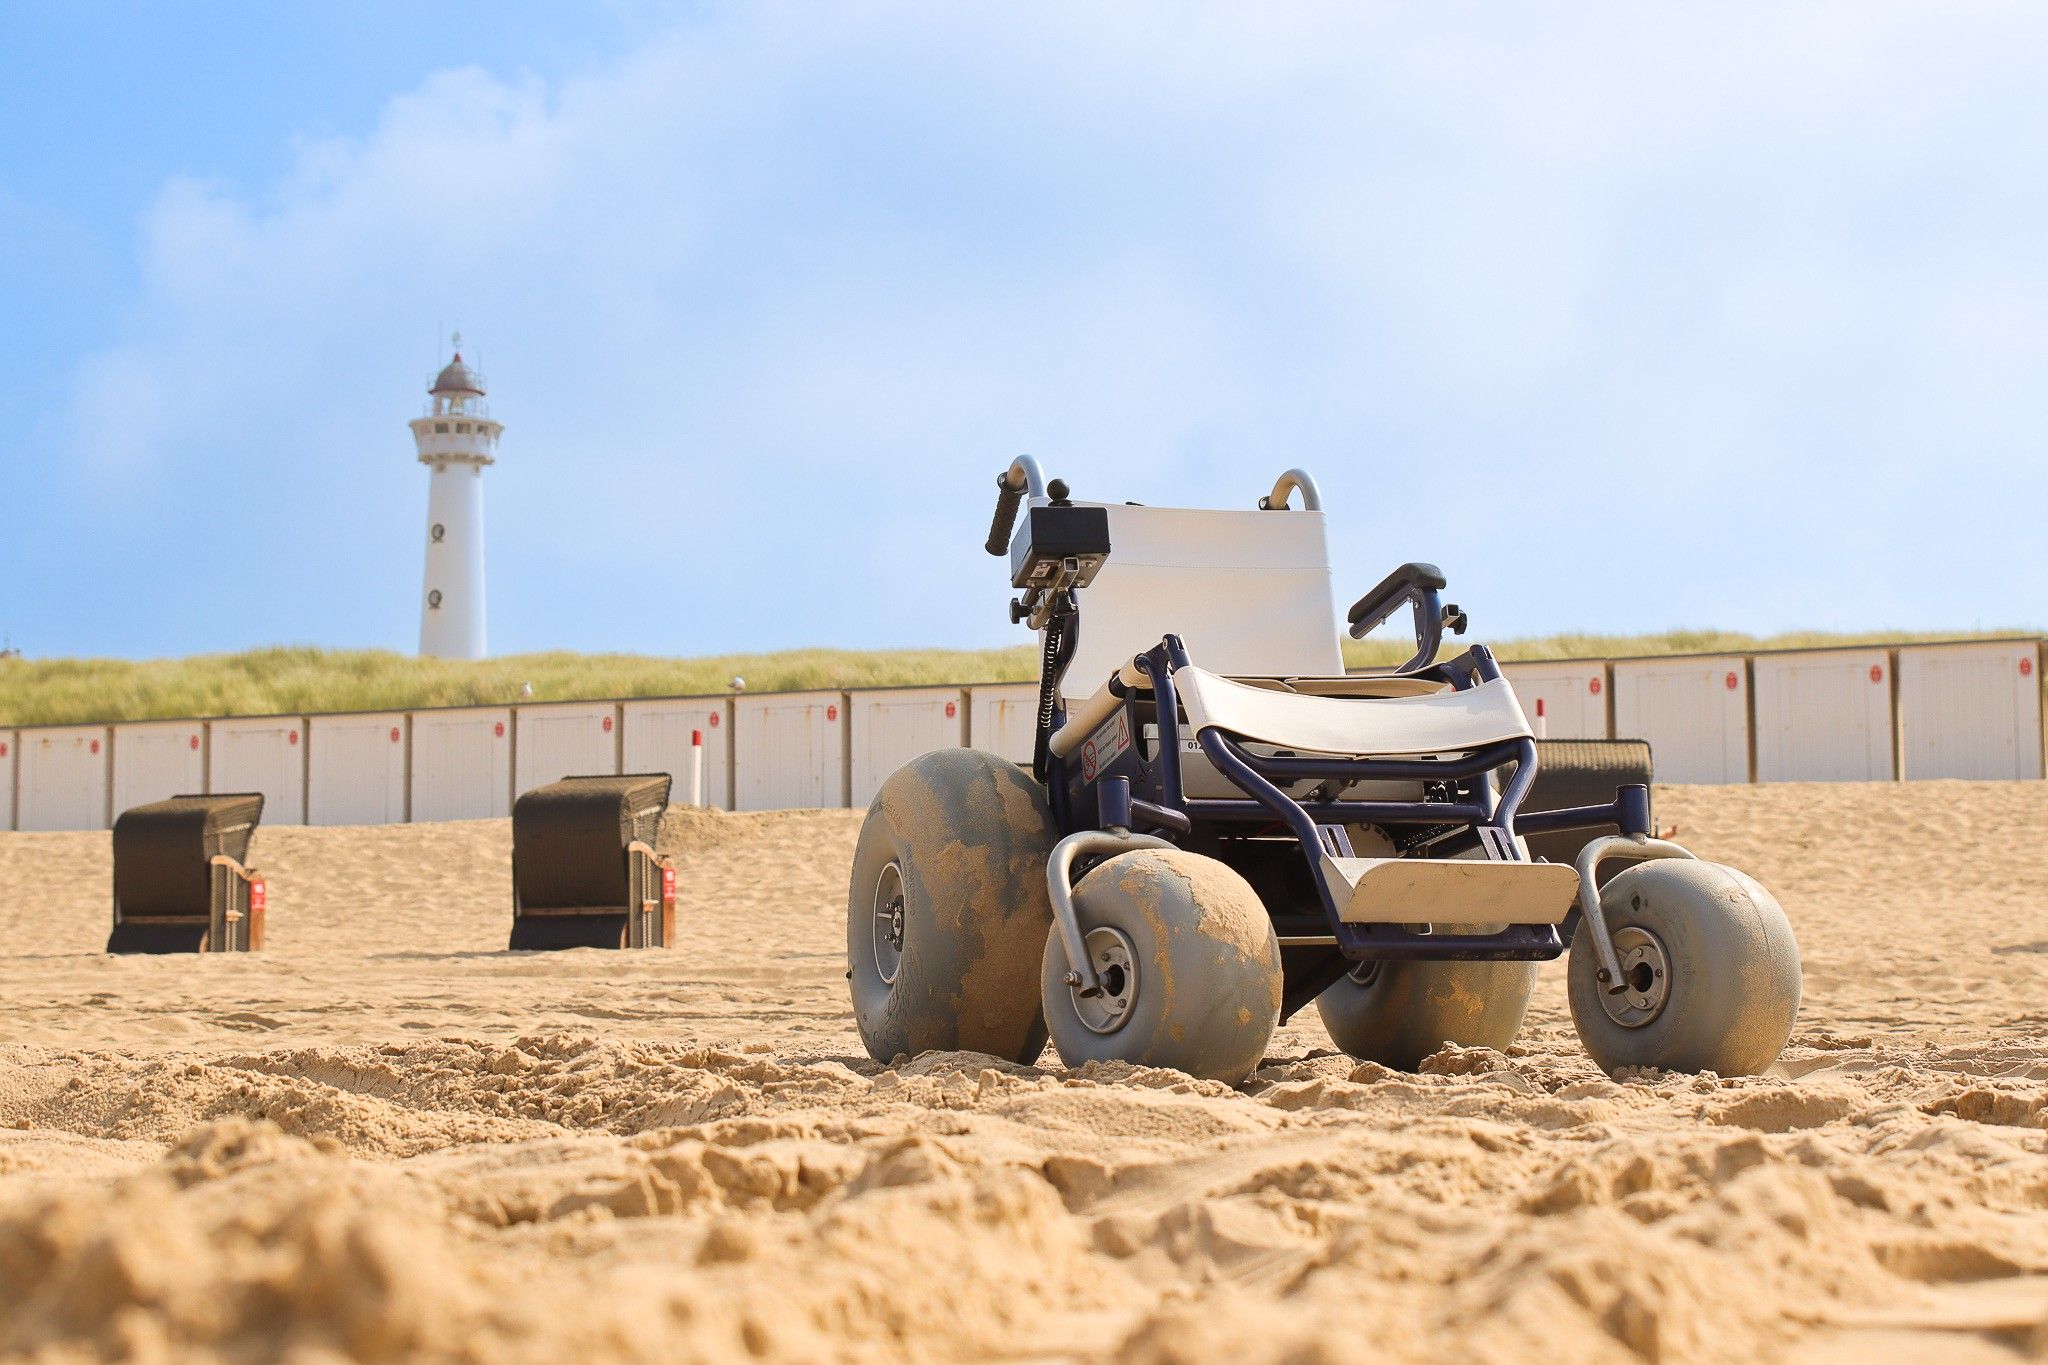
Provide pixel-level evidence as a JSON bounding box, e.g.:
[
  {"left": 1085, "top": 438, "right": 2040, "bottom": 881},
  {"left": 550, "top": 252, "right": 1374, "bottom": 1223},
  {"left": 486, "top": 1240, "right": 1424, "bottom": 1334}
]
[{"left": 1315, "top": 962, "right": 1540, "bottom": 1070}]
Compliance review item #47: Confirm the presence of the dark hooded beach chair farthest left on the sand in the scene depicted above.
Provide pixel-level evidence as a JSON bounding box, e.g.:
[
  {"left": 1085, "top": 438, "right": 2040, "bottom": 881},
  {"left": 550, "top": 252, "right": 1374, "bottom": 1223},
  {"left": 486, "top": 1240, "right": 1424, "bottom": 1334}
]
[{"left": 106, "top": 792, "right": 262, "bottom": 954}]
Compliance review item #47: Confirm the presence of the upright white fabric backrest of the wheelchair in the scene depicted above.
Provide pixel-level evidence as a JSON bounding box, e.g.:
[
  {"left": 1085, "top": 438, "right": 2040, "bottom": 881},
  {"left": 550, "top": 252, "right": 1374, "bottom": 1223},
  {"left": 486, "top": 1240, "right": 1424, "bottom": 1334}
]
[{"left": 1061, "top": 503, "right": 1343, "bottom": 700}]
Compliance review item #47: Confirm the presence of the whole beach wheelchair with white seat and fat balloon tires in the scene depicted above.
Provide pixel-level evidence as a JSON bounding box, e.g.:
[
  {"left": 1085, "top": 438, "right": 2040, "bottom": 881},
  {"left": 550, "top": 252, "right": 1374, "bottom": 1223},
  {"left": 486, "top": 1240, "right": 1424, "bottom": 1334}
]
[{"left": 846, "top": 458, "right": 1800, "bottom": 1083}]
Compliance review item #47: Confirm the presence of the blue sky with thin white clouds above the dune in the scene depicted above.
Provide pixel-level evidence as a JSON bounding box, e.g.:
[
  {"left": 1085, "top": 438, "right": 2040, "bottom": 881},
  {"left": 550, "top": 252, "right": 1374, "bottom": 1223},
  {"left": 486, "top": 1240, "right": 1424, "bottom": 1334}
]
[{"left": 0, "top": 0, "right": 2048, "bottom": 657}]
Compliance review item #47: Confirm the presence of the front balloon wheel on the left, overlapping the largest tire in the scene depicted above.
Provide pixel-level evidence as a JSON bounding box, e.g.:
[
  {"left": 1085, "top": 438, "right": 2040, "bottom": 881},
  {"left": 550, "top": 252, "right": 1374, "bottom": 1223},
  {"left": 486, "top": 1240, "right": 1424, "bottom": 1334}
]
[{"left": 1040, "top": 849, "right": 1280, "bottom": 1085}]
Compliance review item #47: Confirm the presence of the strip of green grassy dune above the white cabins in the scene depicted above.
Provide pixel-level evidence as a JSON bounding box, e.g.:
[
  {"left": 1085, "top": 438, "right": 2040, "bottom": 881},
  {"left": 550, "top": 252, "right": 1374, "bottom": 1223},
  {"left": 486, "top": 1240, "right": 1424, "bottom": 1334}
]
[{"left": 0, "top": 630, "right": 2030, "bottom": 724}]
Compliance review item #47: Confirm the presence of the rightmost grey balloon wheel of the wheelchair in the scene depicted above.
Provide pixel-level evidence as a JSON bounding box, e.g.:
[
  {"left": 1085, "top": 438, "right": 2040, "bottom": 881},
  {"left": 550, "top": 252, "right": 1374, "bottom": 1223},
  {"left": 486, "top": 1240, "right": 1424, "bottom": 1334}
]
[{"left": 1567, "top": 857, "right": 1800, "bottom": 1076}]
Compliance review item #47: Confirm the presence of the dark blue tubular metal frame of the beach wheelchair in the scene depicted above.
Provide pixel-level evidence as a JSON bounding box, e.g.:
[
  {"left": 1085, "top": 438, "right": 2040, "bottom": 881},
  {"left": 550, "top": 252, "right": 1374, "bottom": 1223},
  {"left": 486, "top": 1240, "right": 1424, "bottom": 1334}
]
[{"left": 1047, "top": 634, "right": 1651, "bottom": 962}]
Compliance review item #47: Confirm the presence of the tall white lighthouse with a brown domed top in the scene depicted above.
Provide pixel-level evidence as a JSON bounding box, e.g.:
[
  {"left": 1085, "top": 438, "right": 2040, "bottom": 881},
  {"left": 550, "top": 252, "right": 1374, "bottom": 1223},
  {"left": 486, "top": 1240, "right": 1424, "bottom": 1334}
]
[{"left": 412, "top": 332, "right": 504, "bottom": 659}]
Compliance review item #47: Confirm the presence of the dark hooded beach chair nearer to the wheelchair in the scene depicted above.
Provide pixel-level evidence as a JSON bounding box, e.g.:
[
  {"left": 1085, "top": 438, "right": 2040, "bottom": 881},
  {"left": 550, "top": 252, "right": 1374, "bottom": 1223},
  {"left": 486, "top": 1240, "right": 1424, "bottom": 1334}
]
[{"left": 512, "top": 774, "right": 672, "bottom": 948}]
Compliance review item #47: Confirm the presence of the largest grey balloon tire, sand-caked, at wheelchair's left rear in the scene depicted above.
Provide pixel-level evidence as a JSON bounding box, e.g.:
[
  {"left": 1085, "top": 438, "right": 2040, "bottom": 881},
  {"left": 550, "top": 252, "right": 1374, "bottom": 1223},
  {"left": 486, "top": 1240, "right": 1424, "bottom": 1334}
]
[{"left": 846, "top": 749, "right": 1059, "bottom": 1066}]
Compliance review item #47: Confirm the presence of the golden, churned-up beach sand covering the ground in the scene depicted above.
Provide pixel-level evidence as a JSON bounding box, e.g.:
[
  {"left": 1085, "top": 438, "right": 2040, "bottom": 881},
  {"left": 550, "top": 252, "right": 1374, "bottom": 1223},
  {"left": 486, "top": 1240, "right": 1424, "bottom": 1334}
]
[{"left": 0, "top": 784, "right": 2048, "bottom": 1365}]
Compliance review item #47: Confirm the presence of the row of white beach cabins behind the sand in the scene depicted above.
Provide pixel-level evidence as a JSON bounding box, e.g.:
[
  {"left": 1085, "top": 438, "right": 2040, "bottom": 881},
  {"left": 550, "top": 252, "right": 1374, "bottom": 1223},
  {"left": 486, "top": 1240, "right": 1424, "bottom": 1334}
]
[{"left": 0, "top": 639, "right": 2044, "bottom": 831}]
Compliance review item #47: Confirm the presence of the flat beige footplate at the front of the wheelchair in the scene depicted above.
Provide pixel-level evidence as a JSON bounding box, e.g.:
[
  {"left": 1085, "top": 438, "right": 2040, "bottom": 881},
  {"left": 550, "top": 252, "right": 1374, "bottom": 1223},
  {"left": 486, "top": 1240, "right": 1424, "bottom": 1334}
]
[{"left": 1323, "top": 855, "right": 1579, "bottom": 925}]
